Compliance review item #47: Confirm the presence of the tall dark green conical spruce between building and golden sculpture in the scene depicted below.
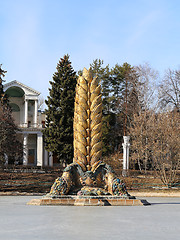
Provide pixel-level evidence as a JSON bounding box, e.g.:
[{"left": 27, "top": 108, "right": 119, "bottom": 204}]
[{"left": 43, "top": 55, "right": 76, "bottom": 163}]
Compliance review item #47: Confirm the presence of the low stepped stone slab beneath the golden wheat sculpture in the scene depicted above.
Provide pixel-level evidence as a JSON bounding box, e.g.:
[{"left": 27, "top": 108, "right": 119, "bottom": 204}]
[{"left": 27, "top": 195, "right": 150, "bottom": 206}]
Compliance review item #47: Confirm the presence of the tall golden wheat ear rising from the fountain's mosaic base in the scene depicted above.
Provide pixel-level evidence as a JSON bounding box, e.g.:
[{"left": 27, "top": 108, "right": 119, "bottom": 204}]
[{"left": 73, "top": 68, "right": 102, "bottom": 171}]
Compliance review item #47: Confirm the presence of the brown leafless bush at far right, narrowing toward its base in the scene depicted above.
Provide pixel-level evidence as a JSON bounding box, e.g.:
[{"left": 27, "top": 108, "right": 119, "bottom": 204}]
[{"left": 150, "top": 112, "right": 180, "bottom": 187}]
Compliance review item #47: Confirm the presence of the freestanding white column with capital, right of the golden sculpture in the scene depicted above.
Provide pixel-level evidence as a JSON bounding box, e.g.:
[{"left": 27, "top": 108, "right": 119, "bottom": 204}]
[{"left": 122, "top": 136, "right": 130, "bottom": 177}]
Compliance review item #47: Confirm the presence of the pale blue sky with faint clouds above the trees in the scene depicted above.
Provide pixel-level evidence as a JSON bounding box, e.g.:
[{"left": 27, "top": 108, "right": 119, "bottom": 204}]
[{"left": 0, "top": 0, "right": 180, "bottom": 98}]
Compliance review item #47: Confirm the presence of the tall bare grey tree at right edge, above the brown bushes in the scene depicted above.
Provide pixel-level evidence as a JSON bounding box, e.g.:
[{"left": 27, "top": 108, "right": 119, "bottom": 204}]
[{"left": 159, "top": 69, "right": 180, "bottom": 111}]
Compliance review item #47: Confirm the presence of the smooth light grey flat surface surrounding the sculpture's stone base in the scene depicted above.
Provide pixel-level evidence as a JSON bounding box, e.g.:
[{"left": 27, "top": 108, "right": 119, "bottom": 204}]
[{"left": 0, "top": 196, "right": 180, "bottom": 240}]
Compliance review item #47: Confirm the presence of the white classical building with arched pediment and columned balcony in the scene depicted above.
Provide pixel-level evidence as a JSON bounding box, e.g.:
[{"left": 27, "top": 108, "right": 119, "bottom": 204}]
[{"left": 4, "top": 80, "right": 55, "bottom": 166}]
